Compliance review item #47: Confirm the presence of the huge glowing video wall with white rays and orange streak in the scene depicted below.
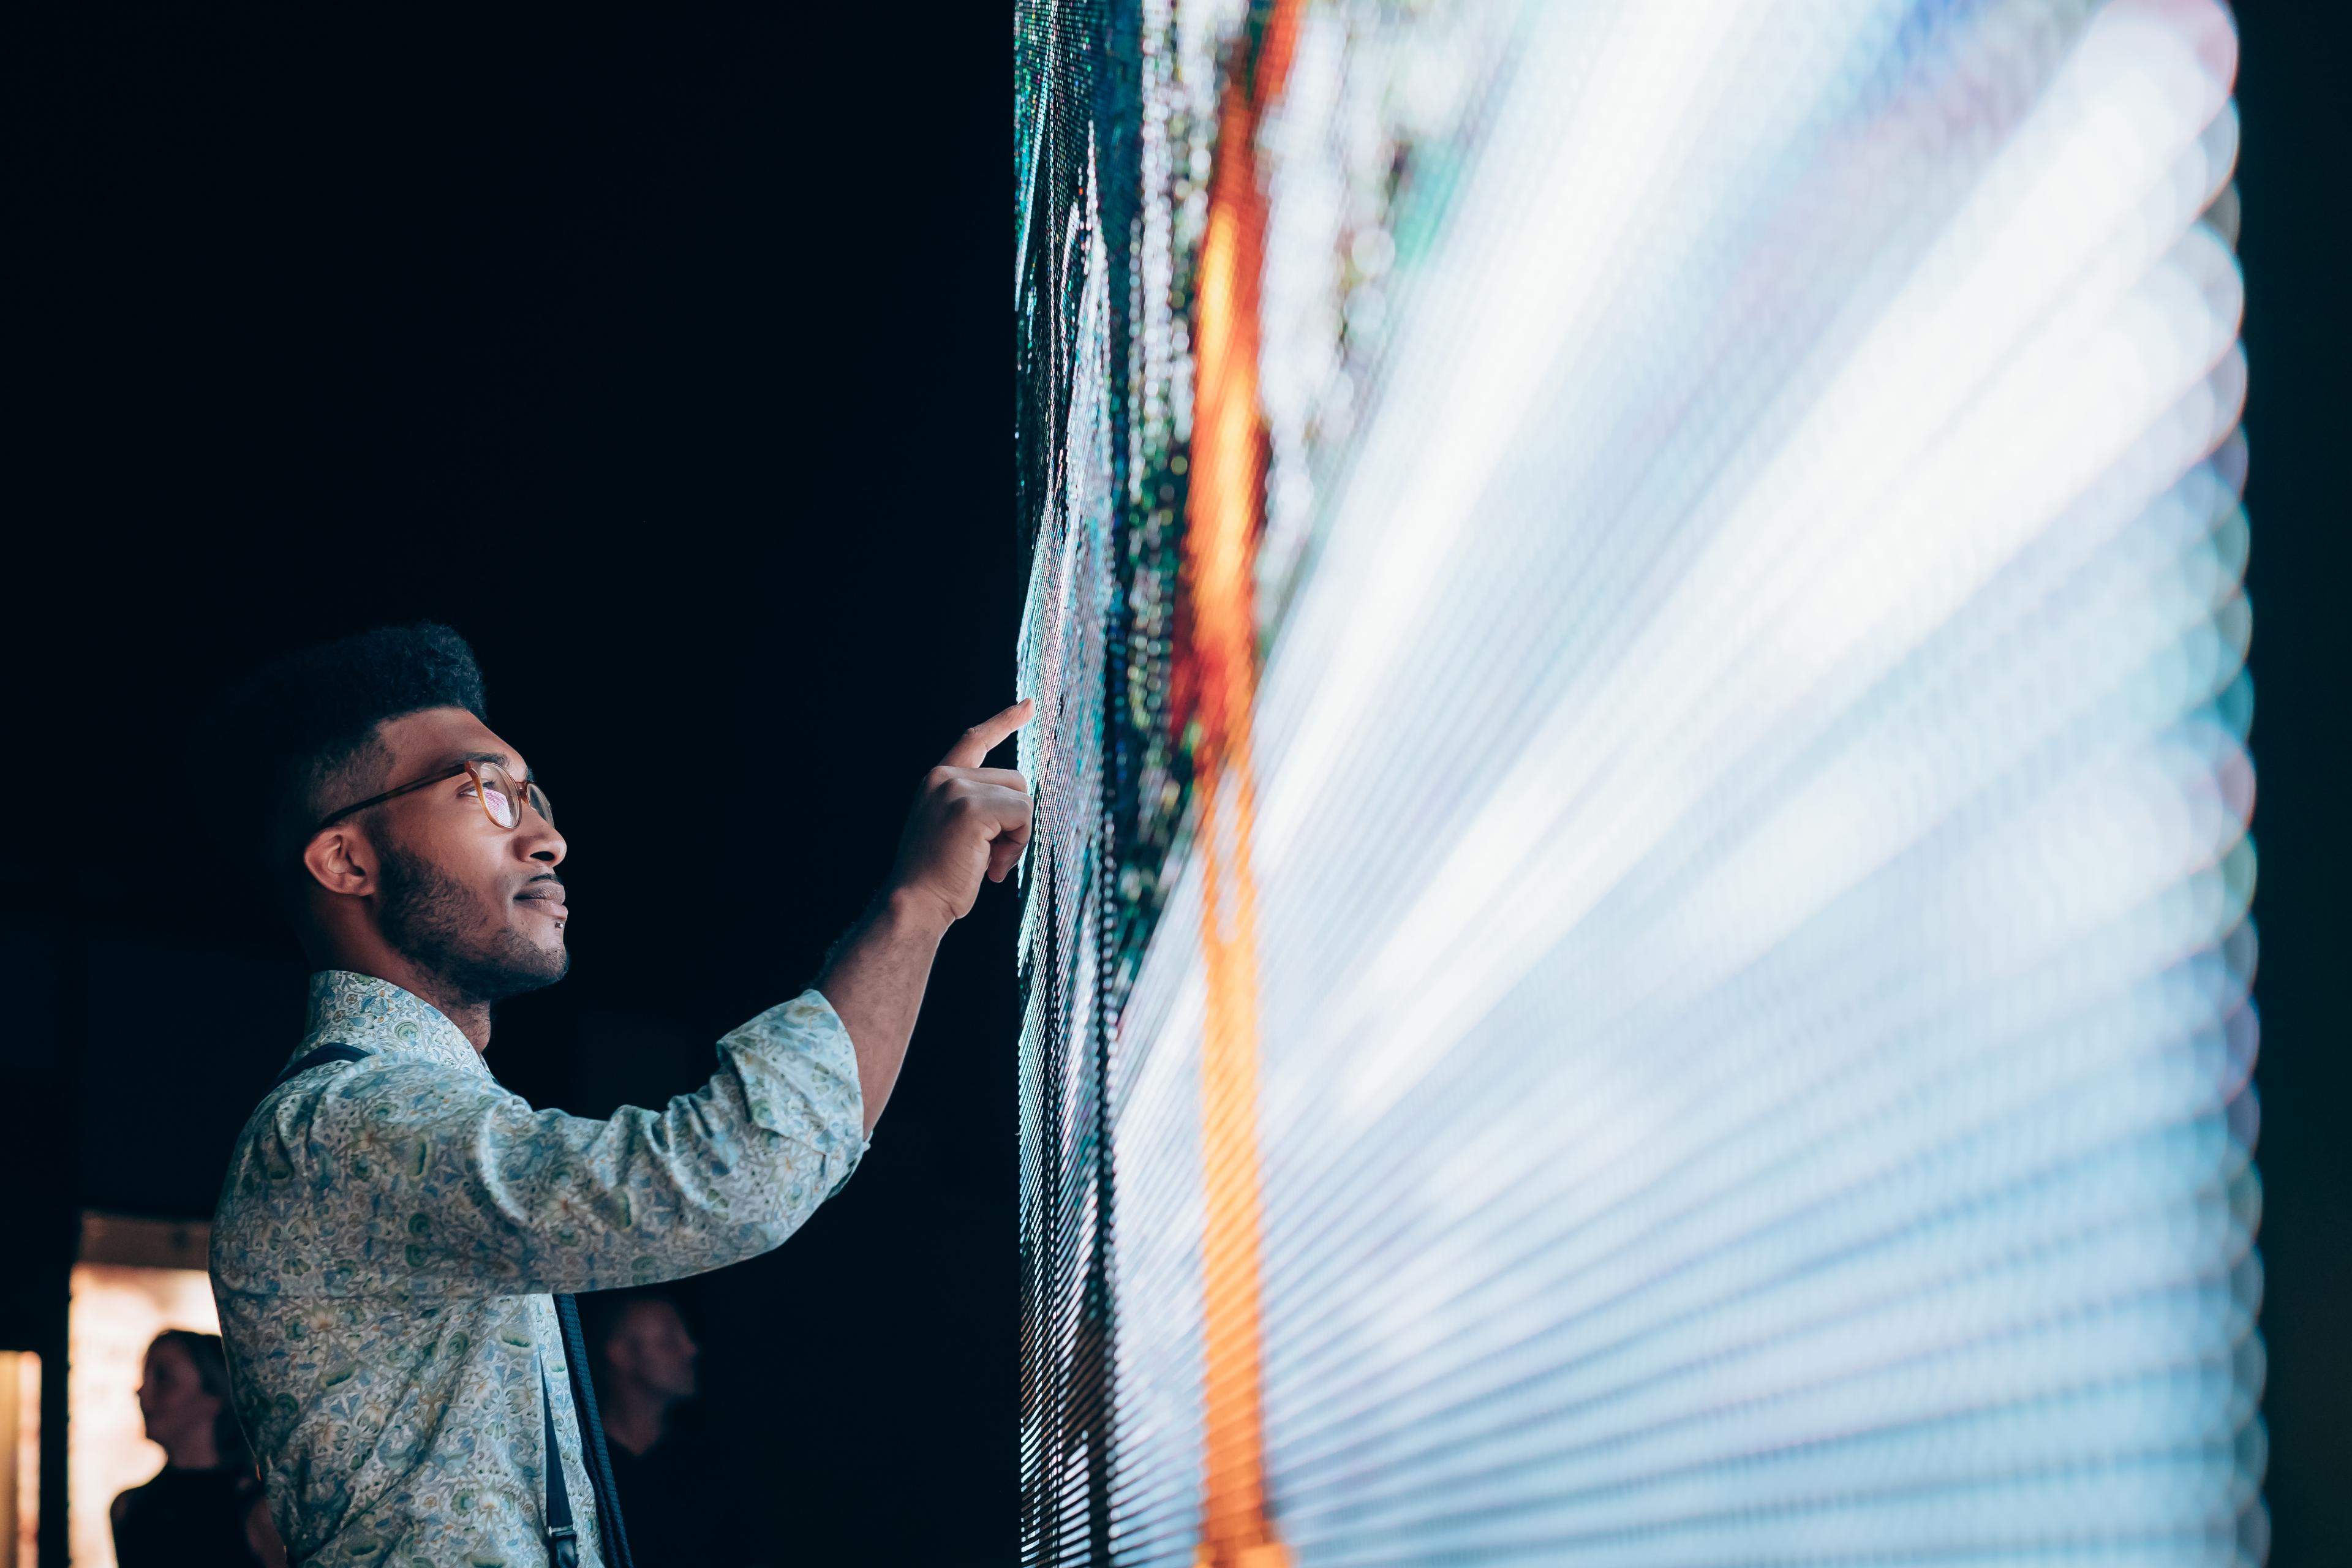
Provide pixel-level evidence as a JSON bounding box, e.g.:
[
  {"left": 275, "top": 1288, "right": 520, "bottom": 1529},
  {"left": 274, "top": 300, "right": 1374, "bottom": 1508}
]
[{"left": 1014, "top": 0, "right": 2265, "bottom": 1568}]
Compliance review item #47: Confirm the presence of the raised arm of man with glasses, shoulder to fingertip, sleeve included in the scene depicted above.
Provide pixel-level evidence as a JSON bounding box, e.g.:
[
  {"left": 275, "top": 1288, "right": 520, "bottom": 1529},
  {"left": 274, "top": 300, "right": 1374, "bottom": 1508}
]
[{"left": 216, "top": 703, "right": 1030, "bottom": 1295}]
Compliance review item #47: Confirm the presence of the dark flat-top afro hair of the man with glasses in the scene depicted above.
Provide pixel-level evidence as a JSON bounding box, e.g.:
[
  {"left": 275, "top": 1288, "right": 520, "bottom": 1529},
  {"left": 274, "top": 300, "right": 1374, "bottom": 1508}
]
[{"left": 198, "top": 620, "right": 489, "bottom": 886}]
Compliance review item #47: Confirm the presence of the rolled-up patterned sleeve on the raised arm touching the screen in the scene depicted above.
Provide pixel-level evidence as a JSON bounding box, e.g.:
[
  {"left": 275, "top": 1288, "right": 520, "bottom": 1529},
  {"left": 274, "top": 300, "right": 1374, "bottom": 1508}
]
[{"left": 238, "top": 990, "right": 865, "bottom": 1295}]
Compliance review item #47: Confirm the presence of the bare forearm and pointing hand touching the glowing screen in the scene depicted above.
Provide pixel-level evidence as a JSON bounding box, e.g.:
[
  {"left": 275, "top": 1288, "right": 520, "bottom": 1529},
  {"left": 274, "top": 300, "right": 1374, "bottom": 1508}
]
[{"left": 816, "top": 701, "right": 1035, "bottom": 1133}]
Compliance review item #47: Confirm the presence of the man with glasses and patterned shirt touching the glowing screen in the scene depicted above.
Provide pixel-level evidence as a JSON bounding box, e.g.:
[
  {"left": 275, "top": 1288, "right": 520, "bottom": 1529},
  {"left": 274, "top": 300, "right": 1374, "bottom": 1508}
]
[{"left": 209, "top": 625, "right": 1030, "bottom": 1568}]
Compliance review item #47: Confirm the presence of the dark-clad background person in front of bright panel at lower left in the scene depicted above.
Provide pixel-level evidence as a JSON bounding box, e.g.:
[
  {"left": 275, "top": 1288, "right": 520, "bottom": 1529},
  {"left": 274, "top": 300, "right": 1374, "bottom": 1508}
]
[{"left": 110, "top": 1329, "right": 287, "bottom": 1568}]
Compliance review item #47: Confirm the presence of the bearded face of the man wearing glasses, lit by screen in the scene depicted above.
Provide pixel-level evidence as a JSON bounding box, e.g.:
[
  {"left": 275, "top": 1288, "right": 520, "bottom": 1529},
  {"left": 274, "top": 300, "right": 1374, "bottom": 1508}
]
[{"left": 341, "top": 707, "right": 571, "bottom": 1001}]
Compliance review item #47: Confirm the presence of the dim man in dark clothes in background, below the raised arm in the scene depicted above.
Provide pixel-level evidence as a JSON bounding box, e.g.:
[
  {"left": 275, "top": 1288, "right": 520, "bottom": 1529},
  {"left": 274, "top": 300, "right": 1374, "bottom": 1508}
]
[{"left": 588, "top": 1293, "right": 786, "bottom": 1568}]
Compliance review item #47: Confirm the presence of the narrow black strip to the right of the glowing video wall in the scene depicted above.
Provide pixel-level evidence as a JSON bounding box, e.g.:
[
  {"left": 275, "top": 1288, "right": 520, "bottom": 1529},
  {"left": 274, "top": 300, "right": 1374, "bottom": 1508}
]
[{"left": 2239, "top": 0, "right": 2352, "bottom": 1568}]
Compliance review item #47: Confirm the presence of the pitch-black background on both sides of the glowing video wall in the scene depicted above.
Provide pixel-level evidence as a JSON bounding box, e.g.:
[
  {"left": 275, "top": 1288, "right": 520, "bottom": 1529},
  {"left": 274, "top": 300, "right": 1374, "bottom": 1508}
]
[{"left": 0, "top": 2, "right": 2352, "bottom": 1566}]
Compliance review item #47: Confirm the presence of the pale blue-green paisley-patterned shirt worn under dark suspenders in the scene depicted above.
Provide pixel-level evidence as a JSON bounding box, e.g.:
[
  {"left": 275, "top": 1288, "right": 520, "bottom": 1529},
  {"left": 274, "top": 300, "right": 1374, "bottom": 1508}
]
[{"left": 212, "top": 971, "right": 865, "bottom": 1568}]
